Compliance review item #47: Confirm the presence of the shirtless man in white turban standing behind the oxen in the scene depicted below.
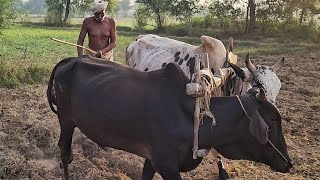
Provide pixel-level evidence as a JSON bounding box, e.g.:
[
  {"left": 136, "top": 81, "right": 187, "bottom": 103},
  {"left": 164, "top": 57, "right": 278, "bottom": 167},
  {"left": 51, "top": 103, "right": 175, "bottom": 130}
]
[{"left": 77, "top": 1, "right": 116, "bottom": 61}]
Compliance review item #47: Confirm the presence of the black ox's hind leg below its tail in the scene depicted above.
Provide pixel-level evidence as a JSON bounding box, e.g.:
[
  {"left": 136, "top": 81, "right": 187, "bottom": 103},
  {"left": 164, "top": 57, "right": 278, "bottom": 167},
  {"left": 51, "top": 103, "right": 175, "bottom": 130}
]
[{"left": 58, "top": 121, "right": 74, "bottom": 180}]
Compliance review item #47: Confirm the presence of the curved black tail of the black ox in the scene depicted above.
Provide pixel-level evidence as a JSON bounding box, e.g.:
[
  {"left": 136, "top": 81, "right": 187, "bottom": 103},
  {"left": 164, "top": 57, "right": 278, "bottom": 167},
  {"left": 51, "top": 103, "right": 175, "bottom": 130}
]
[{"left": 47, "top": 58, "right": 73, "bottom": 114}]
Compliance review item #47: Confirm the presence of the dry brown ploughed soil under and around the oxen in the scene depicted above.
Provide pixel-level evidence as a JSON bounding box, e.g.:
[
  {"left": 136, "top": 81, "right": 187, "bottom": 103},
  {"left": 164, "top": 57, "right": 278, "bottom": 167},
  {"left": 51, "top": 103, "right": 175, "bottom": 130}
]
[{"left": 0, "top": 52, "right": 320, "bottom": 180}]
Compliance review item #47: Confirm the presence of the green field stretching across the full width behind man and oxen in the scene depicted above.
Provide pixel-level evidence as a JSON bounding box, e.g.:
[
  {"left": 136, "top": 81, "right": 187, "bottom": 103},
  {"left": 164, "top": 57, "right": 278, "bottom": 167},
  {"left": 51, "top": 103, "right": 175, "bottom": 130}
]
[{"left": 0, "top": 24, "right": 319, "bottom": 88}]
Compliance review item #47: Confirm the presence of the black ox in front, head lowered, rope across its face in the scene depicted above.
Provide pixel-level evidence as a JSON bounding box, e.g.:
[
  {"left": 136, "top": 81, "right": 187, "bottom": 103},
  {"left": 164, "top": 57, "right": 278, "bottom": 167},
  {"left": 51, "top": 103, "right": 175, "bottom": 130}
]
[{"left": 47, "top": 56, "right": 292, "bottom": 180}]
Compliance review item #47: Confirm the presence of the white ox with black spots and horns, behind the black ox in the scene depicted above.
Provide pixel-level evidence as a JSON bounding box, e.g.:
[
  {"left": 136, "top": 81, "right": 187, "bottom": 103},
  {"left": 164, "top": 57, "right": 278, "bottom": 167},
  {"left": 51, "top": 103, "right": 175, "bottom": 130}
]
[{"left": 126, "top": 34, "right": 284, "bottom": 103}]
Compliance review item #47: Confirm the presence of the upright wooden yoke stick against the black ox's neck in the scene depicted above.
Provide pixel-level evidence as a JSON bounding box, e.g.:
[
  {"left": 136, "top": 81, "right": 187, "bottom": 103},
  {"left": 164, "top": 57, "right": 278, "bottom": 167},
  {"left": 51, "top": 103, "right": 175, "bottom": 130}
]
[{"left": 192, "top": 54, "right": 201, "bottom": 159}]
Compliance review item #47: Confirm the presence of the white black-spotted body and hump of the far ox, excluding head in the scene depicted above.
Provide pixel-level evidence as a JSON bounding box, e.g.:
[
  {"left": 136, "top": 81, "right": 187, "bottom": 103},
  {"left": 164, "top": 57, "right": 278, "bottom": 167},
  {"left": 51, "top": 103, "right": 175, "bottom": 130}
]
[{"left": 126, "top": 34, "right": 226, "bottom": 78}]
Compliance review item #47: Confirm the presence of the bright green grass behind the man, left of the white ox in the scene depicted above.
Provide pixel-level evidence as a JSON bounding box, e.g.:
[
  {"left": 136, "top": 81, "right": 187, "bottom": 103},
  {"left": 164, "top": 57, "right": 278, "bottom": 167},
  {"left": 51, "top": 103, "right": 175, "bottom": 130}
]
[{"left": 0, "top": 25, "right": 137, "bottom": 88}]
